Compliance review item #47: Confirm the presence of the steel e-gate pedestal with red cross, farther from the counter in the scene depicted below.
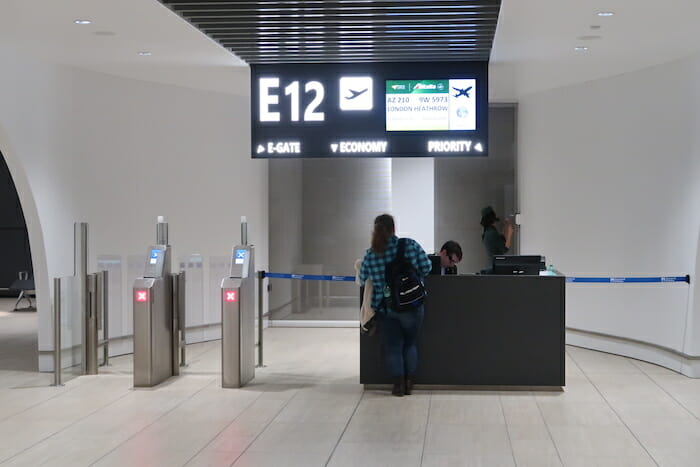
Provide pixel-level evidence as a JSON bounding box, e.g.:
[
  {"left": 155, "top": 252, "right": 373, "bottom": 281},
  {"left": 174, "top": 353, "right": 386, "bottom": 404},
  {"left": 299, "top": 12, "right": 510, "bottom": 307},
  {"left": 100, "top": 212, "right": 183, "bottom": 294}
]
[{"left": 133, "top": 217, "right": 185, "bottom": 387}]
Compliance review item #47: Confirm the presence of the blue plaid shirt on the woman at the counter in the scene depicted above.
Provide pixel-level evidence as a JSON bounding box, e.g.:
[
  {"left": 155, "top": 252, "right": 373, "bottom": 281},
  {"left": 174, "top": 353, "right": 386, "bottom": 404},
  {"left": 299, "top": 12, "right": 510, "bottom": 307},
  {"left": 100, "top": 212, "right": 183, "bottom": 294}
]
[{"left": 360, "top": 235, "right": 433, "bottom": 310}]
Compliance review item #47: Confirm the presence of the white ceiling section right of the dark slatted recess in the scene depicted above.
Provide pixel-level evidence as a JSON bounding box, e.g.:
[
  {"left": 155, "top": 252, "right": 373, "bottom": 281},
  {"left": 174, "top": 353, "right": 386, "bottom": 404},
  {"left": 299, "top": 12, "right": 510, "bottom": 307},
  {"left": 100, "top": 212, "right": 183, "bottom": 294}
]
[{"left": 491, "top": 0, "right": 700, "bottom": 99}]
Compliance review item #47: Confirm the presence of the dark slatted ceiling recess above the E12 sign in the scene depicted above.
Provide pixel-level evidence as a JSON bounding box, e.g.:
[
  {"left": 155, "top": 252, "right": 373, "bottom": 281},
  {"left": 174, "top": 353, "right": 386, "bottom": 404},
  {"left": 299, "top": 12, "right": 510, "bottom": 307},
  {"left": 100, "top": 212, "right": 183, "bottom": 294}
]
[{"left": 160, "top": 0, "right": 501, "bottom": 64}]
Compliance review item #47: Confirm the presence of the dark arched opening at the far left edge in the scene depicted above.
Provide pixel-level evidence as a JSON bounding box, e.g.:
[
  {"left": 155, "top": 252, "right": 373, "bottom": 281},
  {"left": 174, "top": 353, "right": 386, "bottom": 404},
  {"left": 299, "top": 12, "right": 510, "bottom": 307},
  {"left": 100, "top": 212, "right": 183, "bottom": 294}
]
[{"left": 0, "top": 153, "right": 38, "bottom": 372}]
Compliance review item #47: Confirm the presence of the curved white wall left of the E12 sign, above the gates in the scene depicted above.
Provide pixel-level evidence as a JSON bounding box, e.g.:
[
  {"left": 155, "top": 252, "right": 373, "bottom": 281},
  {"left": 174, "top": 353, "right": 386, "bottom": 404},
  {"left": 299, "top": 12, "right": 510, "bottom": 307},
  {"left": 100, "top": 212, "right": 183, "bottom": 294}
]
[{"left": 0, "top": 48, "right": 268, "bottom": 372}]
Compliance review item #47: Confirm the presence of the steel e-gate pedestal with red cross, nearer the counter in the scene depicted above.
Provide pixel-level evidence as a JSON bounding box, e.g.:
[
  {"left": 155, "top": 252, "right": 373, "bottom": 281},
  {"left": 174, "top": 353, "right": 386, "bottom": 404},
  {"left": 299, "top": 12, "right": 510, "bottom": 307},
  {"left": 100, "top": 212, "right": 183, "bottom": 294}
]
[{"left": 221, "top": 245, "right": 262, "bottom": 388}]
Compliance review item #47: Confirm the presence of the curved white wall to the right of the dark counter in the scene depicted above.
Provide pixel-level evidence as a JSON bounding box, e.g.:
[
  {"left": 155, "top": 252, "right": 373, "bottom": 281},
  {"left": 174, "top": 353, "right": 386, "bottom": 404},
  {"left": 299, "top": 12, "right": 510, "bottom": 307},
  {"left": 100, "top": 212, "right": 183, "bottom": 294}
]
[{"left": 518, "top": 51, "right": 700, "bottom": 372}]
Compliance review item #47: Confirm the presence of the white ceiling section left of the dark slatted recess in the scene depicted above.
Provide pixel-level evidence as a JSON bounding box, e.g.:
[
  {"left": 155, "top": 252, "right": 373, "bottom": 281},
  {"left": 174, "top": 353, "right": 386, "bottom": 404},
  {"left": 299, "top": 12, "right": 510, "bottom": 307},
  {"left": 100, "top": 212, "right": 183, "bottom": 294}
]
[{"left": 0, "top": 0, "right": 249, "bottom": 94}]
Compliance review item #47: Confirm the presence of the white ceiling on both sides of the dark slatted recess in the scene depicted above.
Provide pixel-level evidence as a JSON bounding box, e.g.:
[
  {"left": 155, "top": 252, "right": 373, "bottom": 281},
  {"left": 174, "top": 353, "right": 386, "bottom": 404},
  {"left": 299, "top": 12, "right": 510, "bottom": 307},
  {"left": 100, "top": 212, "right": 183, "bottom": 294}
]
[{"left": 0, "top": 0, "right": 700, "bottom": 100}]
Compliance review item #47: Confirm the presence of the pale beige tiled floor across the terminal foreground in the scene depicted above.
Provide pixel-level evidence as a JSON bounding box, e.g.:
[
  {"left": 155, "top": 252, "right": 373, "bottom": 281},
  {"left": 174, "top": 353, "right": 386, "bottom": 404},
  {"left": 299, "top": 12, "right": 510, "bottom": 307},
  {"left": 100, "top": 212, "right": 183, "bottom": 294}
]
[{"left": 0, "top": 308, "right": 700, "bottom": 467}]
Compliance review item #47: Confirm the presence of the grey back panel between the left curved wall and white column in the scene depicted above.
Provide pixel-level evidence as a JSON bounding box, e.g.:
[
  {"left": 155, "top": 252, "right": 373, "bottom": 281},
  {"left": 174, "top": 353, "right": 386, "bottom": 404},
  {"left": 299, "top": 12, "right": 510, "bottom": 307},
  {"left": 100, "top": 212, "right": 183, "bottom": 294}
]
[{"left": 268, "top": 158, "right": 392, "bottom": 326}]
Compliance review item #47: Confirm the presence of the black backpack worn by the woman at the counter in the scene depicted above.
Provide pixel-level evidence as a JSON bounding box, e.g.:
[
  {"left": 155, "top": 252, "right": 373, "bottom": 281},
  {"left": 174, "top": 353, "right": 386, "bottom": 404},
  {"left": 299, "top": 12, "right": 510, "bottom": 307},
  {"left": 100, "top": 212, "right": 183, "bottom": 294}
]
[{"left": 385, "top": 238, "right": 426, "bottom": 312}]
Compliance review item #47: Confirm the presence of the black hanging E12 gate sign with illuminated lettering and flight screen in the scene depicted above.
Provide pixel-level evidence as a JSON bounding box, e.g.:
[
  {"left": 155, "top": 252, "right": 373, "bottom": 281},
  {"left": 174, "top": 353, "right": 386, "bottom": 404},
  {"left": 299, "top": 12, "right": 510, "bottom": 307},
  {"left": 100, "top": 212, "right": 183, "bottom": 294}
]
[{"left": 251, "top": 62, "right": 488, "bottom": 158}]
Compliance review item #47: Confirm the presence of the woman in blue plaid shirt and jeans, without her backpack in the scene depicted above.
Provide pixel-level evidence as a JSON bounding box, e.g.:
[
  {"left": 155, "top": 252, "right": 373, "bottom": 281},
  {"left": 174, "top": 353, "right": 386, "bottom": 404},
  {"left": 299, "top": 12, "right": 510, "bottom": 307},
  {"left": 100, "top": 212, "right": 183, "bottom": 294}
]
[{"left": 360, "top": 214, "right": 432, "bottom": 397}]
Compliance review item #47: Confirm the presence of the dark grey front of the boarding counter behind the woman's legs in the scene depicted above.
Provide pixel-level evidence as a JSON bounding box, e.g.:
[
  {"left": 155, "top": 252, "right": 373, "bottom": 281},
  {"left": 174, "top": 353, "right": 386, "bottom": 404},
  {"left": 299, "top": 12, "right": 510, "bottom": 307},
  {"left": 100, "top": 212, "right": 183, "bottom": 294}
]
[{"left": 360, "top": 275, "right": 565, "bottom": 386}]
